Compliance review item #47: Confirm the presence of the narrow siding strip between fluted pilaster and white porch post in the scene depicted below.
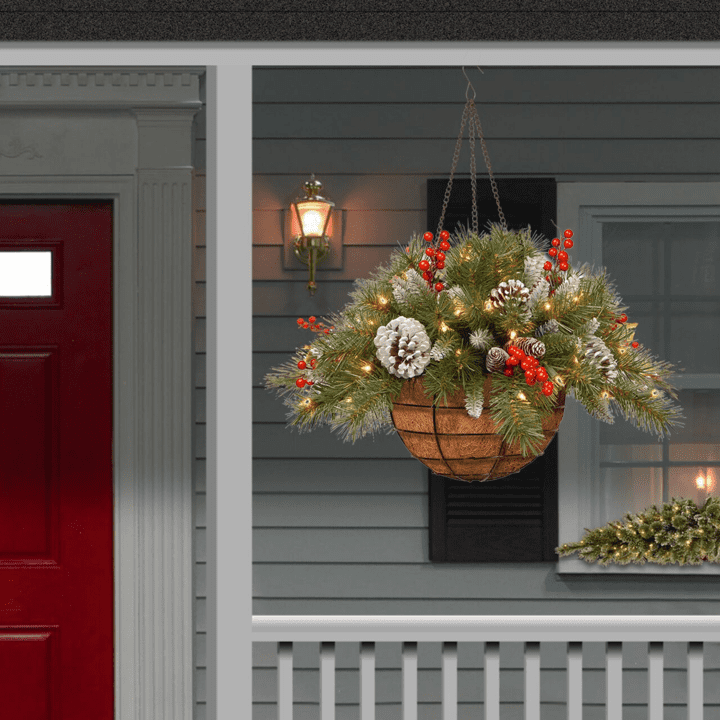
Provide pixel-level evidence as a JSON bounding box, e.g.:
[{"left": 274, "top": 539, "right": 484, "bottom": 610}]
[{"left": 192, "top": 75, "right": 207, "bottom": 720}]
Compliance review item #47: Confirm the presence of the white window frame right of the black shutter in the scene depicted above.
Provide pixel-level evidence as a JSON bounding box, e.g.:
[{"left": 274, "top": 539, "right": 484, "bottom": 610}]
[{"left": 557, "top": 182, "right": 720, "bottom": 575}]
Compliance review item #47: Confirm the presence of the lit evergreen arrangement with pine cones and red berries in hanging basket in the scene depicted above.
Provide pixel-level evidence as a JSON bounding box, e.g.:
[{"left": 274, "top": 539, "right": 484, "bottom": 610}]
[{"left": 266, "top": 225, "right": 681, "bottom": 455}]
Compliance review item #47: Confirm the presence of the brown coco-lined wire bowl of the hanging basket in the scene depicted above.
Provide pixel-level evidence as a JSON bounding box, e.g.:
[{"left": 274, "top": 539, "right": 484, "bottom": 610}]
[{"left": 392, "top": 377, "right": 565, "bottom": 482}]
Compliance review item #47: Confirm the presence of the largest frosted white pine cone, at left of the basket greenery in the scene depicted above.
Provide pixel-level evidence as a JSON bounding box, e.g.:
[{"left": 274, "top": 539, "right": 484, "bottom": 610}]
[{"left": 374, "top": 315, "right": 430, "bottom": 379}]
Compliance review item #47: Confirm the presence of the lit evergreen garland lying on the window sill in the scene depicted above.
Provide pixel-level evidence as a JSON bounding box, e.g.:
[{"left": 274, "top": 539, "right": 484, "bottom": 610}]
[{"left": 556, "top": 497, "right": 720, "bottom": 565}]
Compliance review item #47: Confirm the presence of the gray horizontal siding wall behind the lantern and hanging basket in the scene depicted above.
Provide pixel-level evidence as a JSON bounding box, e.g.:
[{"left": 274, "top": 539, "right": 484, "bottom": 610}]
[{"left": 252, "top": 67, "right": 720, "bottom": 615}]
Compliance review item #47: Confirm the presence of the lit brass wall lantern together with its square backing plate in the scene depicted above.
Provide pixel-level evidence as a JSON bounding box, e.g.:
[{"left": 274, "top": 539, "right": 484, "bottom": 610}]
[{"left": 284, "top": 175, "right": 342, "bottom": 294}]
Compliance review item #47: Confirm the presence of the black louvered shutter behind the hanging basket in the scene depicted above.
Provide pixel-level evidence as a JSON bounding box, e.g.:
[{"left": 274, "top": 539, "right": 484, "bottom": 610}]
[{"left": 427, "top": 178, "right": 558, "bottom": 562}]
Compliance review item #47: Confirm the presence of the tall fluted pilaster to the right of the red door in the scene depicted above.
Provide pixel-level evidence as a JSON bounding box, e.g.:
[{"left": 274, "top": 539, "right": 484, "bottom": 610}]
[{"left": 137, "top": 150, "right": 193, "bottom": 720}]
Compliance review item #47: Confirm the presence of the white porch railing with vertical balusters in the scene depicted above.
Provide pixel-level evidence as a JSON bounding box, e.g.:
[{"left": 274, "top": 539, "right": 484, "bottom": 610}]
[{"left": 253, "top": 616, "right": 720, "bottom": 720}]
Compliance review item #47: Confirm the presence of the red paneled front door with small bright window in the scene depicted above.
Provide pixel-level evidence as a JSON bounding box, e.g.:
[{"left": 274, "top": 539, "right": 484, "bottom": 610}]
[{"left": 0, "top": 201, "right": 113, "bottom": 720}]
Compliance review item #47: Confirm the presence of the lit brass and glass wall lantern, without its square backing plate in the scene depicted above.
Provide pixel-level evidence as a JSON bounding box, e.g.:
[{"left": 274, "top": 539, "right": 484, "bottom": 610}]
[{"left": 287, "top": 175, "right": 335, "bottom": 294}]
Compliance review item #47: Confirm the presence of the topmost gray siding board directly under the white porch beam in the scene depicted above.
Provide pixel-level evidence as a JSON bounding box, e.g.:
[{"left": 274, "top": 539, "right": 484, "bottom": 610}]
[{"left": 253, "top": 66, "right": 720, "bottom": 104}]
